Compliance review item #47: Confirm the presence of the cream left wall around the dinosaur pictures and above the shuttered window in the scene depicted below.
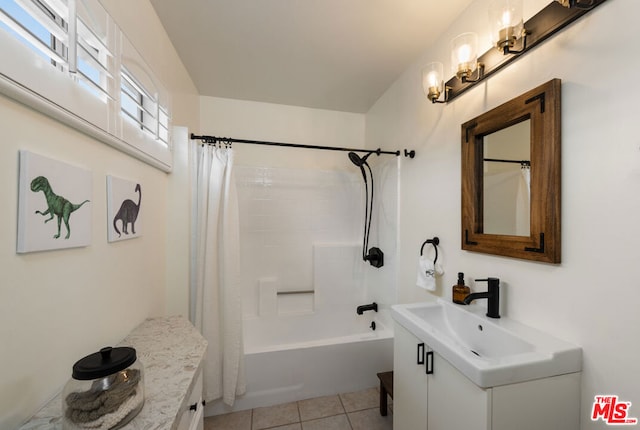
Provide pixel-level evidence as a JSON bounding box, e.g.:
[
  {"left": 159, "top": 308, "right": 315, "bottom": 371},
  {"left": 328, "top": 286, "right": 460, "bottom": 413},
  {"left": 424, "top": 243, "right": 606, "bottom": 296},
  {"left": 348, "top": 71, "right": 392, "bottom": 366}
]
[{"left": 0, "top": 0, "right": 199, "bottom": 429}]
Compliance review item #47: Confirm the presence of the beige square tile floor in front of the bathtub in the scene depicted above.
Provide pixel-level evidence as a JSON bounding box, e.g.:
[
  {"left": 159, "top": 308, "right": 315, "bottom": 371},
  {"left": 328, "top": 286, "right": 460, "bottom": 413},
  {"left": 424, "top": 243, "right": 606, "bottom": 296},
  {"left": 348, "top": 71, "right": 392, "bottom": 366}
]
[{"left": 204, "top": 388, "right": 393, "bottom": 430}]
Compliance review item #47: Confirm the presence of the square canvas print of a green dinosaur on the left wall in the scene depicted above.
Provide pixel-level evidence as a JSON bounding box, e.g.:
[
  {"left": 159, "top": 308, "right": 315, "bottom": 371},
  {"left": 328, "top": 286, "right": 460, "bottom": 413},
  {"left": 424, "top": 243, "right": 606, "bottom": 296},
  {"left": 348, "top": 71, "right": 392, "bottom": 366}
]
[{"left": 16, "top": 150, "right": 93, "bottom": 253}]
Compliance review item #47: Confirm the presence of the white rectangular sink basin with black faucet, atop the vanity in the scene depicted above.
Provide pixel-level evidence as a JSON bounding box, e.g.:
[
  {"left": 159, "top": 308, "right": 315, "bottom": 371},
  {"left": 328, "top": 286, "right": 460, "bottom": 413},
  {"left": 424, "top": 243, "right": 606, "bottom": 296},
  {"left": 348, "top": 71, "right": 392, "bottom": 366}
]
[{"left": 391, "top": 299, "right": 582, "bottom": 388}]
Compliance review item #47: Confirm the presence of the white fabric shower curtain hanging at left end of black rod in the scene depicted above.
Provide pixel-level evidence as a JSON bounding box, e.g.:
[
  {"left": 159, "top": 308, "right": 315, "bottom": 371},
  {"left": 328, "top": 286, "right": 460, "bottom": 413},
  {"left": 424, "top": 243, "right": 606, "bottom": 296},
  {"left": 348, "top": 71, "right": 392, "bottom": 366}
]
[{"left": 191, "top": 143, "right": 246, "bottom": 406}]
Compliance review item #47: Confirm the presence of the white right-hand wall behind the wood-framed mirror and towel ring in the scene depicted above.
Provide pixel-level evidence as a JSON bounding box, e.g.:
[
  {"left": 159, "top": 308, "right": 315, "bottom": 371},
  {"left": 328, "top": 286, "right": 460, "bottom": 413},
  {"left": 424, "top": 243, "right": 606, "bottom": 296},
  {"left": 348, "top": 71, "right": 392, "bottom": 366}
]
[{"left": 366, "top": 0, "right": 640, "bottom": 429}]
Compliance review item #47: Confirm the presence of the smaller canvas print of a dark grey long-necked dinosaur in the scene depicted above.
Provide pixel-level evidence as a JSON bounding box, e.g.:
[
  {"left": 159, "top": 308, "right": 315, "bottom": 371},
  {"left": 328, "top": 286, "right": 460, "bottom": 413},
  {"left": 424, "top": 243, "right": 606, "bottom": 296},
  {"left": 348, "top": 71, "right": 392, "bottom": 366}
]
[{"left": 107, "top": 175, "right": 143, "bottom": 242}]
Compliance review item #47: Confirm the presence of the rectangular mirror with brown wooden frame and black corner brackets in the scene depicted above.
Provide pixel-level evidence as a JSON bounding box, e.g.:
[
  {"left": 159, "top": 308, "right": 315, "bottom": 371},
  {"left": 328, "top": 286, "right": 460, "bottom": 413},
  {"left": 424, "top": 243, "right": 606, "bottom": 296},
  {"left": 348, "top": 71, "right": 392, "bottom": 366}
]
[{"left": 462, "top": 79, "right": 561, "bottom": 263}]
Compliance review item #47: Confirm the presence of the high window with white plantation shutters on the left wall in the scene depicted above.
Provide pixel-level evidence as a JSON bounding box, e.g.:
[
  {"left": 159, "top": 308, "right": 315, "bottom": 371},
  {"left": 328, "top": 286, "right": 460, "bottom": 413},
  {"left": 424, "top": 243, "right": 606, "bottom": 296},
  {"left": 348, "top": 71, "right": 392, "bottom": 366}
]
[{"left": 0, "top": 0, "right": 172, "bottom": 171}]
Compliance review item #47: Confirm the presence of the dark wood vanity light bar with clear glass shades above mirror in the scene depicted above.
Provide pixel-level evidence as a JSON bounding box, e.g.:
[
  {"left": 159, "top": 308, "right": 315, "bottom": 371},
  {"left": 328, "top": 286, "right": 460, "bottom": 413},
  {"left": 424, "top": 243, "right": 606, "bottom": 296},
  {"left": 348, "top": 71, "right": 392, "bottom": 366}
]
[{"left": 422, "top": 0, "right": 607, "bottom": 103}]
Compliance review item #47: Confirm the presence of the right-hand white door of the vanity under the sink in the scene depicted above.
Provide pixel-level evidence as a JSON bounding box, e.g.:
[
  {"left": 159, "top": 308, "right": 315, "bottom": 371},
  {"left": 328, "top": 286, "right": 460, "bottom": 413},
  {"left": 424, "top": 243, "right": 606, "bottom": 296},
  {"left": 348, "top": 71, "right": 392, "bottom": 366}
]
[{"left": 424, "top": 352, "right": 491, "bottom": 430}]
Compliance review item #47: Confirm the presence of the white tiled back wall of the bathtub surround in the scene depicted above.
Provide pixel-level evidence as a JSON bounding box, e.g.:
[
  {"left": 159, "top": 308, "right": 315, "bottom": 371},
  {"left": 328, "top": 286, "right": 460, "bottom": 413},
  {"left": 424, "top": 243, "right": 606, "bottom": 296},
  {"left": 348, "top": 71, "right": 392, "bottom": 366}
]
[{"left": 236, "top": 166, "right": 365, "bottom": 318}]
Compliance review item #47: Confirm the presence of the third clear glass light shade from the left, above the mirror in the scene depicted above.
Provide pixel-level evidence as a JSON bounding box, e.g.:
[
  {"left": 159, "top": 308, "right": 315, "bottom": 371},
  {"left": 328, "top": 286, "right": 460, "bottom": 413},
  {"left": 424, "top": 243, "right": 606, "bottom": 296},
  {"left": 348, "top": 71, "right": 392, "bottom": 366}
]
[{"left": 489, "top": 0, "right": 524, "bottom": 51}]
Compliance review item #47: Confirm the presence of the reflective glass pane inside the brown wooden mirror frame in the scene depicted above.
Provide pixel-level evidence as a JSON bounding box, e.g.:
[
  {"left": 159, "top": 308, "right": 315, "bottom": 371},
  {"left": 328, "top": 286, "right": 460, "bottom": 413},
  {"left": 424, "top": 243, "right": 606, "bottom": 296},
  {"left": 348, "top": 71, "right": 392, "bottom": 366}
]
[{"left": 482, "top": 119, "right": 531, "bottom": 236}]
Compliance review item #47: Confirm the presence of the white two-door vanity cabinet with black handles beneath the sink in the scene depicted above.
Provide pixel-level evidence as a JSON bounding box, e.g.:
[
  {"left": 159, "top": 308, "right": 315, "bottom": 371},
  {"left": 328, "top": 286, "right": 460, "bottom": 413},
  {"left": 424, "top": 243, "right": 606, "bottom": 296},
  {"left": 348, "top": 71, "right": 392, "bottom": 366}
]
[{"left": 393, "top": 323, "right": 580, "bottom": 430}]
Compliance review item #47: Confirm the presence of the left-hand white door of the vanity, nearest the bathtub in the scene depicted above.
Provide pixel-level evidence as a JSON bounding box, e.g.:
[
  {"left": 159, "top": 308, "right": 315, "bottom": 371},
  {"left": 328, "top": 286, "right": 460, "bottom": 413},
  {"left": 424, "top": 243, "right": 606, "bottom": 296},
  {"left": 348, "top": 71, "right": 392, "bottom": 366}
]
[{"left": 393, "top": 323, "right": 427, "bottom": 430}]
